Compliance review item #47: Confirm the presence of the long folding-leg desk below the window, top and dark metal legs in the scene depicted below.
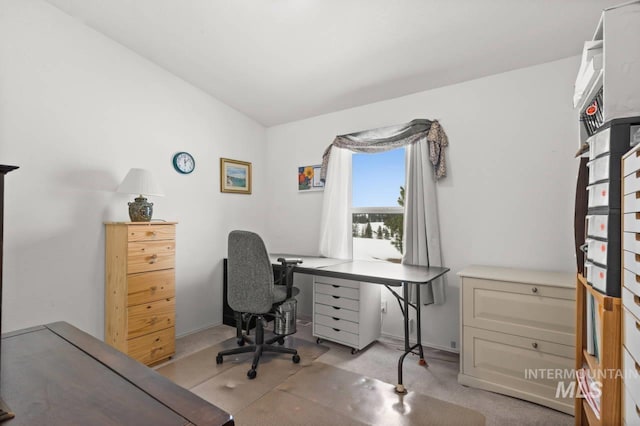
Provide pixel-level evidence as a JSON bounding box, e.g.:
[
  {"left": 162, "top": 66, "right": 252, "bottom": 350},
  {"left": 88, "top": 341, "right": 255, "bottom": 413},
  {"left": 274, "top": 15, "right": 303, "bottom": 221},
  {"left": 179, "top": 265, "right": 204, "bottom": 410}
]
[{"left": 269, "top": 253, "right": 449, "bottom": 393}]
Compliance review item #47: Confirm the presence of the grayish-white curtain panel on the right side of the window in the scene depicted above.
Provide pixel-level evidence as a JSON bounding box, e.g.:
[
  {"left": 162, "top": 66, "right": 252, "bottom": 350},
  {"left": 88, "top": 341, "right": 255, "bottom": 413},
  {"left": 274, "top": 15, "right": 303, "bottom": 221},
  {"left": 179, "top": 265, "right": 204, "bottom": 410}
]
[{"left": 402, "top": 136, "right": 445, "bottom": 305}]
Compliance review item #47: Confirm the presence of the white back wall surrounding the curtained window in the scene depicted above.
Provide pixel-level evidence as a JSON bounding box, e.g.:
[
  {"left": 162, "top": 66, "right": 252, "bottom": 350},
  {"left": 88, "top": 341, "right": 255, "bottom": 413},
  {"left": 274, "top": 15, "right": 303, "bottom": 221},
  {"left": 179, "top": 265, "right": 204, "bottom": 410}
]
[{"left": 267, "top": 58, "right": 578, "bottom": 348}]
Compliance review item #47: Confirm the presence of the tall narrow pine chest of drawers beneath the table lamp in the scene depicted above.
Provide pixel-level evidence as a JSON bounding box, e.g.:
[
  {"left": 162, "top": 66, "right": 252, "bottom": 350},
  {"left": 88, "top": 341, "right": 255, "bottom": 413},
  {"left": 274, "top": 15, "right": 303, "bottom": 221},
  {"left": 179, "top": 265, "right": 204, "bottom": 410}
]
[{"left": 104, "top": 222, "right": 176, "bottom": 365}]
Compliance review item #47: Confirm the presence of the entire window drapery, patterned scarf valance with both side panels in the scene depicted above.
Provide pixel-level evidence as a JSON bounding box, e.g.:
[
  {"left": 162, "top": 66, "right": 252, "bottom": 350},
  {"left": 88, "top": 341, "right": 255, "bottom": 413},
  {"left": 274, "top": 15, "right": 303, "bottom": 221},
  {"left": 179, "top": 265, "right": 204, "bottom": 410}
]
[{"left": 320, "top": 119, "right": 449, "bottom": 304}]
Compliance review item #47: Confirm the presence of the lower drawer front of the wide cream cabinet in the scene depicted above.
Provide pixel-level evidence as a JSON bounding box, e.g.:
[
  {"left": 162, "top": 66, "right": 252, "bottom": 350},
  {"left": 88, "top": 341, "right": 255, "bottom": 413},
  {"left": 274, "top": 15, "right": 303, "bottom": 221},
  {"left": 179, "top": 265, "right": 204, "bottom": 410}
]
[{"left": 463, "top": 327, "right": 575, "bottom": 404}]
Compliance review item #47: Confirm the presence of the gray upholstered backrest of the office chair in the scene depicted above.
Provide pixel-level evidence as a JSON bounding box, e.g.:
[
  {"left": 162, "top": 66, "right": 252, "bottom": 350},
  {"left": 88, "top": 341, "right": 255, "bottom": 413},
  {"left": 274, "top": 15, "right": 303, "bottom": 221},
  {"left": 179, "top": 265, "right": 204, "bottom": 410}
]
[{"left": 227, "top": 231, "right": 274, "bottom": 314}]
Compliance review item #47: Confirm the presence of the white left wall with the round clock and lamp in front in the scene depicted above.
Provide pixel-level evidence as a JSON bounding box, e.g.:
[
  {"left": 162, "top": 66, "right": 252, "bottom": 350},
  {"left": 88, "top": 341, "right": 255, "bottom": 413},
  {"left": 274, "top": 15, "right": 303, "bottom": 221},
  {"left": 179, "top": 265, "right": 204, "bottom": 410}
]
[{"left": 0, "top": 0, "right": 267, "bottom": 337}]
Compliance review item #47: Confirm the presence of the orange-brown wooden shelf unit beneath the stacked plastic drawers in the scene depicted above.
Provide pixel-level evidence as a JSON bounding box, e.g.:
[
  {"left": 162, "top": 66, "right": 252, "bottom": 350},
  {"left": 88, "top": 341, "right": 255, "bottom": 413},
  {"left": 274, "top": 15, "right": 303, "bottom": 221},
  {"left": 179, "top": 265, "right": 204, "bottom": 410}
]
[{"left": 575, "top": 274, "right": 622, "bottom": 426}]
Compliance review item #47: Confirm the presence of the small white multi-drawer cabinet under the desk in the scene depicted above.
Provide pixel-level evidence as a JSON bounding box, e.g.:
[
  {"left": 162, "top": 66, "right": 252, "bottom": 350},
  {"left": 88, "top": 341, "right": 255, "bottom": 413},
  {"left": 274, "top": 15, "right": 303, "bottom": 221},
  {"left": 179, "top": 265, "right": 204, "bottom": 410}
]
[{"left": 313, "top": 276, "right": 381, "bottom": 353}]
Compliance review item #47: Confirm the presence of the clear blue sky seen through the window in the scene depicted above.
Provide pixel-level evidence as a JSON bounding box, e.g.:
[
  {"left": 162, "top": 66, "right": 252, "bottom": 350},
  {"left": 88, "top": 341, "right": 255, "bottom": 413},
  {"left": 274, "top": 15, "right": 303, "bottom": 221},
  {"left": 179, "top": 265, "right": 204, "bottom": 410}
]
[{"left": 353, "top": 148, "right": 404, "bottom": 207}]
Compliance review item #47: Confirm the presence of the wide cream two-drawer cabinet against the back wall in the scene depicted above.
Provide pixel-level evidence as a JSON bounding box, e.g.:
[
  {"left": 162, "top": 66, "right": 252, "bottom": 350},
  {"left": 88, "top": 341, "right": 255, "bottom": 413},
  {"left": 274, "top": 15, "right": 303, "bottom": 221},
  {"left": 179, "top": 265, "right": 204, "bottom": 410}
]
[{"left": 458, "top": 266, "right": 576, "bottom": 414}]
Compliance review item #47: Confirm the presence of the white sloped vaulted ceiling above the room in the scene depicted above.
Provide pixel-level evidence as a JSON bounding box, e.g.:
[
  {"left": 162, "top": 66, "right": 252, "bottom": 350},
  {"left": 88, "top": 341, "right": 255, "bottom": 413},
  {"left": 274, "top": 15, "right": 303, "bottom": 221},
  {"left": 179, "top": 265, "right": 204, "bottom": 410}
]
[{"left": 48, "top": 0, "right": 621, "bottom": 126}]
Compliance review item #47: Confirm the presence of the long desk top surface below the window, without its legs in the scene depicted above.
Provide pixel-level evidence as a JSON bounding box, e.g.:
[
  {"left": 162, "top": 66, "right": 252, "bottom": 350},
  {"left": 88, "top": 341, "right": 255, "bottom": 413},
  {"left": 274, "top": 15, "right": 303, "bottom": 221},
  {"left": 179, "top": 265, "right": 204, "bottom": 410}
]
[{"left": 270, "top": 254, "right": 449, "bottom": 286}]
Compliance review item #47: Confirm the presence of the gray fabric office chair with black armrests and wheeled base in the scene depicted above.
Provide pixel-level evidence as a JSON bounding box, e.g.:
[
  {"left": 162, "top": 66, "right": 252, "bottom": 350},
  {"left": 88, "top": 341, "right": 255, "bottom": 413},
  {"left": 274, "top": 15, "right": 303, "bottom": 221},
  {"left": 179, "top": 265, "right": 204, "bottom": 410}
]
[{"left": 216, "top": 231, "right": 300, "bottom": 379}]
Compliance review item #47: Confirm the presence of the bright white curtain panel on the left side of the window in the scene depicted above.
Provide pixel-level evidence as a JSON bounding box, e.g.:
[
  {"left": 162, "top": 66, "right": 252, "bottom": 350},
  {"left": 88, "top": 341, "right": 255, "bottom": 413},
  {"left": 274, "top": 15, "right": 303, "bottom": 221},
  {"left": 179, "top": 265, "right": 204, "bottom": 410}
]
[{"left": 320, "top": 147, "right": 353, "bottom": 259}]
